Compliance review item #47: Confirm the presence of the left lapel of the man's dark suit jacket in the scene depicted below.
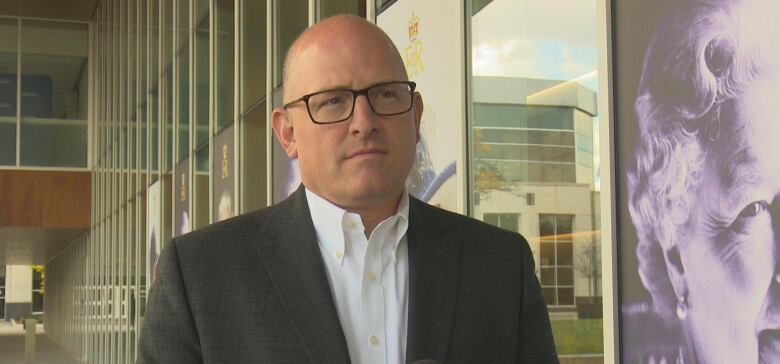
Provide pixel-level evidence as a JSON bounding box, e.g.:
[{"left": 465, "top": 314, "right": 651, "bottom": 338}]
[{"left": 258, "top": 186, "right": 350, "bottom": 363}]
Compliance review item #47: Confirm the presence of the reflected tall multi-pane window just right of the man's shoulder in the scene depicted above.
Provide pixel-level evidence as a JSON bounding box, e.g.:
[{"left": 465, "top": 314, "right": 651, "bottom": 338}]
[{"left": 539, "top": 215, "right": 574, "bottom": 306}]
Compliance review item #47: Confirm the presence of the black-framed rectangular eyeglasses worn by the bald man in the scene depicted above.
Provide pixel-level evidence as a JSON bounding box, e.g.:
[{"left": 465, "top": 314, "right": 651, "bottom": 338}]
[{"left": 284, "top": 81, "right": 417, "bottom": 124}]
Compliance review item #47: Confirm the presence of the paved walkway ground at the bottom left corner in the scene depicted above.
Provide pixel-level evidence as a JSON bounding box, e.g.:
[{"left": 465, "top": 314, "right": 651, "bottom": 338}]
[{"left": 0, "top": 321, "right": 81, "bottom": 364}]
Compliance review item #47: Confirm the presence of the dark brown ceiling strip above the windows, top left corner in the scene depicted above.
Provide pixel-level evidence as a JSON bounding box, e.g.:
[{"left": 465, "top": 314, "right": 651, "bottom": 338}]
[{"left": 0, "top": 0, "right": 97, "bottom": 21}]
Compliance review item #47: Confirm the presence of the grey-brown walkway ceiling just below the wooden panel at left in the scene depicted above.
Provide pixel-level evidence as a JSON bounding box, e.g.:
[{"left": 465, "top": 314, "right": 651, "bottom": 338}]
[{"left": 0, "top": 227, "right": 86, "bottom": 265}]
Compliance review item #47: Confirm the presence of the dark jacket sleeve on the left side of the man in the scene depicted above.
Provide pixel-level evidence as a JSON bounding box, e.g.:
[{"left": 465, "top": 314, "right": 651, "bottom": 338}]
[{"left": 138, "top": 240, "right": 203, "bottom": 364}]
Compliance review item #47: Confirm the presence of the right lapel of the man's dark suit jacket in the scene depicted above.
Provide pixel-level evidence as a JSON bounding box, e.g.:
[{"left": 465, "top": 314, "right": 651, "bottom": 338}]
[{"left": 406, "top": 198, "right": 460, "bottom": 362}]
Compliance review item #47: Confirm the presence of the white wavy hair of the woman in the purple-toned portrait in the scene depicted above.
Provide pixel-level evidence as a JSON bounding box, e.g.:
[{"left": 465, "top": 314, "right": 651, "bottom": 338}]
[{"left": 628, "top": 0, "right": 780, "bottom": 317}]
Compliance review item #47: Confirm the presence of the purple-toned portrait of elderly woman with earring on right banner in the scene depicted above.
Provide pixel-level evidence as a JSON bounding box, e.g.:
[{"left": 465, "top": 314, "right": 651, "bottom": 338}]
[{"left": 621, "top": 0, "right": 780, "bottom": 363}]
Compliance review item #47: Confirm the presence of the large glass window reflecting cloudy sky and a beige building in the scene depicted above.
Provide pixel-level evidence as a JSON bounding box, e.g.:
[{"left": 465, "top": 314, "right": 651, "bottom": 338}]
[{"left": 468, "top": 0, "right": 604, "bottom": 360}]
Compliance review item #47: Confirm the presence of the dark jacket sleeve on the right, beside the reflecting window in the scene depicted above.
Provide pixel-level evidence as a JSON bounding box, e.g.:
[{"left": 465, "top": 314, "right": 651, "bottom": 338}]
[{"left": 517, "top": 238, "right": 558, "bottom": 363}]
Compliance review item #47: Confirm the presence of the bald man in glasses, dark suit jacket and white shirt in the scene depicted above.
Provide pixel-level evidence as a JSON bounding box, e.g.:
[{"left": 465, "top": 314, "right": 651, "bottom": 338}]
[{"left": 140, "top": 16, "right": 557, "bottom": 363}]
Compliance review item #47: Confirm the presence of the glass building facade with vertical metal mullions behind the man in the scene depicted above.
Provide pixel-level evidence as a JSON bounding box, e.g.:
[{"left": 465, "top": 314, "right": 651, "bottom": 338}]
[{"left": 25, "top": 0, "right": 613, "bottom": 363}]
